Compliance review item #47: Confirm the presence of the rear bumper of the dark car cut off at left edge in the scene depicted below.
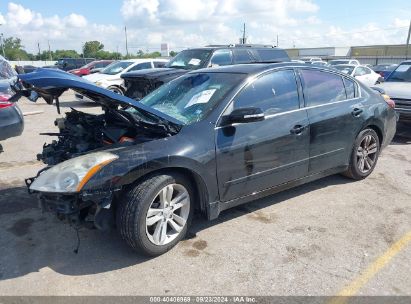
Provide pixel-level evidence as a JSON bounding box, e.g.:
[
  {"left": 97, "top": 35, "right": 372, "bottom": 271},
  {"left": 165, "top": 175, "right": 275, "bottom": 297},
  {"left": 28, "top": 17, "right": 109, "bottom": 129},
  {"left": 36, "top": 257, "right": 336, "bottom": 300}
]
[{"left": 0, "top": 105, "right": 24, "bottom": 140}]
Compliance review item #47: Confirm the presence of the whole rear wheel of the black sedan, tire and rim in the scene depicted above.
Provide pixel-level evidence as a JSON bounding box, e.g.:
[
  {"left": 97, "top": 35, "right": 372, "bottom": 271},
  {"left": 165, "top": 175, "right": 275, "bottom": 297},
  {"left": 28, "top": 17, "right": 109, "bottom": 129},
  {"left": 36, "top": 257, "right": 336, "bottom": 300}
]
[{"left": 343, "top": 129, "right": 380, "bottom": 180}]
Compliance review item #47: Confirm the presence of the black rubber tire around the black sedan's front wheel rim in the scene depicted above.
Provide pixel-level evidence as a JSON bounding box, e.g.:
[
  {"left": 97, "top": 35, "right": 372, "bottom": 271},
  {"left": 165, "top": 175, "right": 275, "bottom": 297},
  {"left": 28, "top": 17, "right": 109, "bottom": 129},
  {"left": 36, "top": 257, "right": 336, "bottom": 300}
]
[{"left": 116, "top": 173, "right": 194, "bottom": 256}]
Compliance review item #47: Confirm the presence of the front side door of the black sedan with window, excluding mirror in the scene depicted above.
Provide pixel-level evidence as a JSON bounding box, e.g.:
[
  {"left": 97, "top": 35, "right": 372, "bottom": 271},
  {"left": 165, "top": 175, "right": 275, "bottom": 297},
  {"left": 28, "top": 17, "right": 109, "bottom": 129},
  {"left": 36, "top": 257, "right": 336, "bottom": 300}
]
[{"left": 216, "top": 69, "right": 309, "bottom": 201}]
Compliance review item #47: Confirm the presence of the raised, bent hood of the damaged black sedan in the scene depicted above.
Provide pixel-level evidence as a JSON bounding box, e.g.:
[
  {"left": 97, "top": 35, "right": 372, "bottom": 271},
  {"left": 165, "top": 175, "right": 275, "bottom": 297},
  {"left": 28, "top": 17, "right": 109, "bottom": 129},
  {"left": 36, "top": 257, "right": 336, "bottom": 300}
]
[{"left": 18, "top": 69, "right": 182, "bottom": 125}]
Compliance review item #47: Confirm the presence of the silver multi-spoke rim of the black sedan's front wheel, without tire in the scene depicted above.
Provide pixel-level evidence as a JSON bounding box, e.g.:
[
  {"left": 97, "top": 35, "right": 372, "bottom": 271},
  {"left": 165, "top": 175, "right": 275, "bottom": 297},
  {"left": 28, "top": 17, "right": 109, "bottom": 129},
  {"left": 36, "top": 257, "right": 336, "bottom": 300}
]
[{"left": 146, "top": 184, "right": 190, "bottom": 245}]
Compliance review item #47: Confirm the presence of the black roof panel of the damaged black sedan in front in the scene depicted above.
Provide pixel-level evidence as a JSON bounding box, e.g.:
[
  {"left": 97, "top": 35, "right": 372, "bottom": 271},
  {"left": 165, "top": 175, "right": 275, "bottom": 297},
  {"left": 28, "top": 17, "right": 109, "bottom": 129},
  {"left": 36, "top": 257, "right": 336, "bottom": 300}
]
[{"left": 190, "top": 62, "right": 335, "bottom": 75}]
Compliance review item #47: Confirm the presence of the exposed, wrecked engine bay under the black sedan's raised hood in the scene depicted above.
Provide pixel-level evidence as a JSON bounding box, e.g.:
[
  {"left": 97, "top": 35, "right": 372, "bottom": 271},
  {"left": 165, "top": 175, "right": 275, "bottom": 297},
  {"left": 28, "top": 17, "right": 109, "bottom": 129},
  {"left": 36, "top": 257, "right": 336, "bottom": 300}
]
[{"left": 37, "top": 108, "right": 179, "bottom": 166}]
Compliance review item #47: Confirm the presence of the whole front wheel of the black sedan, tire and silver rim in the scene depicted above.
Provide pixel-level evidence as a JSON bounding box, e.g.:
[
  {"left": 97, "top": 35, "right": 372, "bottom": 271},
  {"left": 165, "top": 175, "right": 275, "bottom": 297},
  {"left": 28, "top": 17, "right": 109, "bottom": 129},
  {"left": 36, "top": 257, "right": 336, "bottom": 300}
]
[{"left": 116, "top": 174, "right": 193, "bottom": 256}]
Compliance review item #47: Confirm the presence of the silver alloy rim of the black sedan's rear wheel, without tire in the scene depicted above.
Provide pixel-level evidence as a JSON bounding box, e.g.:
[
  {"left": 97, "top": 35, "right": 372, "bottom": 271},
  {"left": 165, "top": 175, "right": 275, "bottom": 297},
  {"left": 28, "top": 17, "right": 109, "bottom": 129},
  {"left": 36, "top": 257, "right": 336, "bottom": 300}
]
[{"left": 357, "top": 134, "right": 378, "bottom": 174}]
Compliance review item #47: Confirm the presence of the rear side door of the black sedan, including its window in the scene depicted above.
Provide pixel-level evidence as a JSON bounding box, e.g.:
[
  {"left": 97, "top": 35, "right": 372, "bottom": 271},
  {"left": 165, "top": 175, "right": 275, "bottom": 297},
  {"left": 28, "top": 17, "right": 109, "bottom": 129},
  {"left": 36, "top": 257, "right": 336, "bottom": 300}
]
[{"left": 299, "top": 69, "right": 364, "bottom": 174}]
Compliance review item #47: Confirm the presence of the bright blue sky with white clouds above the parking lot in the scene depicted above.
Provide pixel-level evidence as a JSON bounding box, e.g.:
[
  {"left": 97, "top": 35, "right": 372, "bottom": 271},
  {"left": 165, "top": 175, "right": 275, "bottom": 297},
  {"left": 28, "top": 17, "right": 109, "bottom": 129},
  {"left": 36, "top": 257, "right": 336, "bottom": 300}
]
[{"left": 0, "top": 0, "right": 411, "bottom": 53}]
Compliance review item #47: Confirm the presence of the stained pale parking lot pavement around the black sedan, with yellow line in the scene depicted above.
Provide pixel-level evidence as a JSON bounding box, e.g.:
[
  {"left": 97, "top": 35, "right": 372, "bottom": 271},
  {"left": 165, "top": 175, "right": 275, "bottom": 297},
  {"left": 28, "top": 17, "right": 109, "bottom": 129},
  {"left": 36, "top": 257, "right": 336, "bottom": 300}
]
[{"left": 0, "top": 94, "right": 411, "bottom": 295}]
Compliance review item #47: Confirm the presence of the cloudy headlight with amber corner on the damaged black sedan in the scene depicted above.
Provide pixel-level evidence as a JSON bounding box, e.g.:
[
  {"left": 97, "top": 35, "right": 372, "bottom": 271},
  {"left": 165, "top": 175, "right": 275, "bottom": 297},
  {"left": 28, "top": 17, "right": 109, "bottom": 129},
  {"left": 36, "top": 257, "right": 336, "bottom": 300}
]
[{"left": 30, "top": 152, "right": 118, "bottom": 193}]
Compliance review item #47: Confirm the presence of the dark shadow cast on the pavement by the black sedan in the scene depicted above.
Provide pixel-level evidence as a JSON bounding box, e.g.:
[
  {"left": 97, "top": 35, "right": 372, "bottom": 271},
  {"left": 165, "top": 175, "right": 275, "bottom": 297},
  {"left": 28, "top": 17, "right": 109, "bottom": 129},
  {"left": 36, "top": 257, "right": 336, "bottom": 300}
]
[{"left": 0, "top": 175, "right": 350, "bottom": 280}]
